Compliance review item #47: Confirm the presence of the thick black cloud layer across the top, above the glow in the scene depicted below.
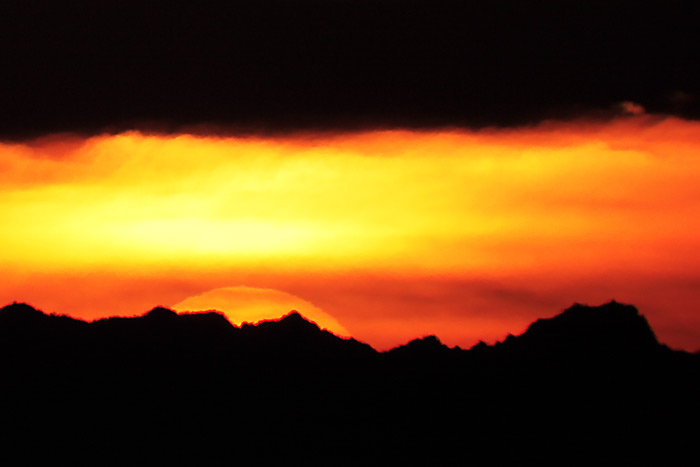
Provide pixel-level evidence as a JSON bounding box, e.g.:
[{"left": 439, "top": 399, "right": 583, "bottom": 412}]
[{"left": 0, "top": 0, "right": 700, "bottom": 139}]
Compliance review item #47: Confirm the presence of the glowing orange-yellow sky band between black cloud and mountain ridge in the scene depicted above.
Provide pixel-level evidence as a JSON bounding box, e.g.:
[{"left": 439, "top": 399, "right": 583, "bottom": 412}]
[{"left": 0, "top": 115, "right": 700, "bottom": 350}]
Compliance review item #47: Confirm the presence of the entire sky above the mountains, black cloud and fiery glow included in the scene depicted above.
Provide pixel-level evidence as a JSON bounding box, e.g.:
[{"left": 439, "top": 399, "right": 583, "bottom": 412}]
[{"left": 0, "top": 0, "right": 700, "bottom": 350}]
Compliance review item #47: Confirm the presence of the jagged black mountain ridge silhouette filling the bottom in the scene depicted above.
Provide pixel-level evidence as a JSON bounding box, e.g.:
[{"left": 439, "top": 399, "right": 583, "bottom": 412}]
[{"left": 0, "top": 302, "right": 700, "bottom": 465}]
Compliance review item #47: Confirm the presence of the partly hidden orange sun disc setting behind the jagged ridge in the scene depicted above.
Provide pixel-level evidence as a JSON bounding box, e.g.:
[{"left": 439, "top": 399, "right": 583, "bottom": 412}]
[{"left": 171, "top": 286, "right": 350, "bottom": 337}]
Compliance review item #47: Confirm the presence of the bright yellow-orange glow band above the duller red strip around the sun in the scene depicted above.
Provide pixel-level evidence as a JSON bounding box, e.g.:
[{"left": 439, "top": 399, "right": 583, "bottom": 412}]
[{"left": 5, "top": 122, "right": 700, "bottom": 271}]
